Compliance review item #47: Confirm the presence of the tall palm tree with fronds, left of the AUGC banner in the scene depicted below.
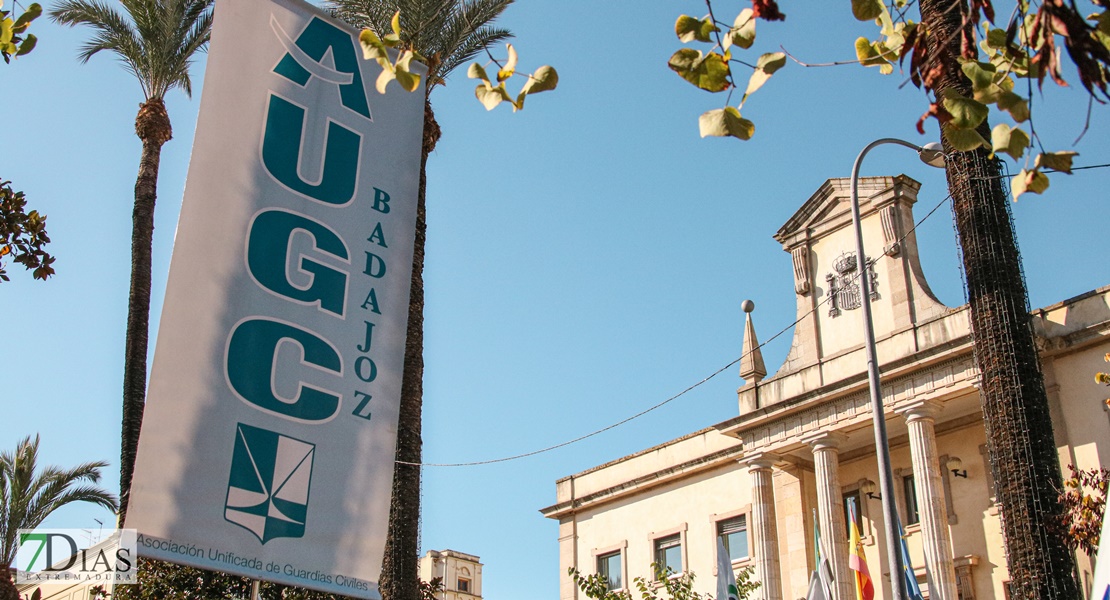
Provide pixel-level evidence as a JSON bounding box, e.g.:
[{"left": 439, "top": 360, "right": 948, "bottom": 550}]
[{"left": 50, "top": 0, "right": 212, "bottom": 523}]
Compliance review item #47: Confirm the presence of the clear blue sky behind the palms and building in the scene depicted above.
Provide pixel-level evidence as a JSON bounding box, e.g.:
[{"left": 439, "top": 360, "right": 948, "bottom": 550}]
[{"left": 0, "top": 0, "right": 1110, "bottom": 600}]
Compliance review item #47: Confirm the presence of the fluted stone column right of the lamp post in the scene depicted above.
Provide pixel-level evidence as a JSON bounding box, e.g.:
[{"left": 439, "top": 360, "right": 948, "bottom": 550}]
[{"left": 898, "top": 400, "right": 957, "bottom": 600}]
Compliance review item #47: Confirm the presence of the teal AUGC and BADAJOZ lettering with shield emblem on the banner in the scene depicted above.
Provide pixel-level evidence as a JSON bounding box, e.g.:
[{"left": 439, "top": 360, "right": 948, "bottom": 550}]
[{"left": 224, "top": 11, "right": 390, "bottom": 543}]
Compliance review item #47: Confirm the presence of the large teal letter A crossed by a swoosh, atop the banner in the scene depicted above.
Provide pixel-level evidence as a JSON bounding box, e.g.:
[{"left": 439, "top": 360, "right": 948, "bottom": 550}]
[{"left": 274, "top": 17, "right": 370, "bottom": 119}]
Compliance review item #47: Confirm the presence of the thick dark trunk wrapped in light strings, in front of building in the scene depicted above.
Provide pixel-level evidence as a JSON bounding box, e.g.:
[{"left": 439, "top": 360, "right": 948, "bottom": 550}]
[{"left": 921, "top": 0, "right": 1080, "bottom": 599}]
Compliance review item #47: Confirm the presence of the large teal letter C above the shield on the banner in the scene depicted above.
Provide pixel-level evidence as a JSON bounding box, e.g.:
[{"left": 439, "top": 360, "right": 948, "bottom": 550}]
[{"left": 226, "top": 317, "right": 343, "bottom": 421}]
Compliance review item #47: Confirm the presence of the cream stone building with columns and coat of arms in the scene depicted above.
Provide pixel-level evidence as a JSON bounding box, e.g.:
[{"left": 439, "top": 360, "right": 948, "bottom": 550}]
[{"left": 542, "top": 175, "right": 1110, "bottom": 600}]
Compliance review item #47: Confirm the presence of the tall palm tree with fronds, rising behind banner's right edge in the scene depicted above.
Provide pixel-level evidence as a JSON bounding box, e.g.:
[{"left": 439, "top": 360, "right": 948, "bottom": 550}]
[{"left": 329, "top": 0, "right": 513, "bottom": 600}]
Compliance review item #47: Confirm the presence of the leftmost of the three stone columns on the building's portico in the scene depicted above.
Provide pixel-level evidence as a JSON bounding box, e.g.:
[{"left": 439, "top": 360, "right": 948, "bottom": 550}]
[{"left": 740, "top": 452, "right": 783, "bottom": 600}]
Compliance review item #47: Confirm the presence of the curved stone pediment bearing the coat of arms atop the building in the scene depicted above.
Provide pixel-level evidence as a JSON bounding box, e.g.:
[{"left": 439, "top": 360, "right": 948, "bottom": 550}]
[{"left": 739, "top": 175, "right": 968, "bottom": 414}]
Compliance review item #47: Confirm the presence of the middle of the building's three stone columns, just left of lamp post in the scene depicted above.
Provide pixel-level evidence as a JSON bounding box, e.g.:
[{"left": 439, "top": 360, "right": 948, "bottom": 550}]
[{"left": 803, "top": 431, "right": 856, "bottom": 600}]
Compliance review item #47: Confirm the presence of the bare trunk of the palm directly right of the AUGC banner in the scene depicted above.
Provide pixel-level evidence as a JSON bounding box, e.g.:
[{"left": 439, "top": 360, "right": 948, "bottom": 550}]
[{"left": 379, "top": 98, "right": 440, "bottom": 600}]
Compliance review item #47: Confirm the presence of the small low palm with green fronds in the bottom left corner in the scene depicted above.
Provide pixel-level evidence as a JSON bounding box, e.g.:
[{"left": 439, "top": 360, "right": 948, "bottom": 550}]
[{"left": 0, "top": 436, "right": 118, "bottom": 600}]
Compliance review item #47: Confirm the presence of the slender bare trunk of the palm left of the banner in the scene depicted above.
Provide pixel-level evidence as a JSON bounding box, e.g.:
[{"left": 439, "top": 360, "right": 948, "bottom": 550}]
[{"left": 119, "top": 98, "right": 172, "bottom": 527}]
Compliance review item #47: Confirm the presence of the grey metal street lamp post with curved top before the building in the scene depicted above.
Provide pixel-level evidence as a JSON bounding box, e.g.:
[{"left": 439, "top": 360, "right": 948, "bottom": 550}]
[{"left": 850, "top": 138, "right": 947, "bottom": 600}]
